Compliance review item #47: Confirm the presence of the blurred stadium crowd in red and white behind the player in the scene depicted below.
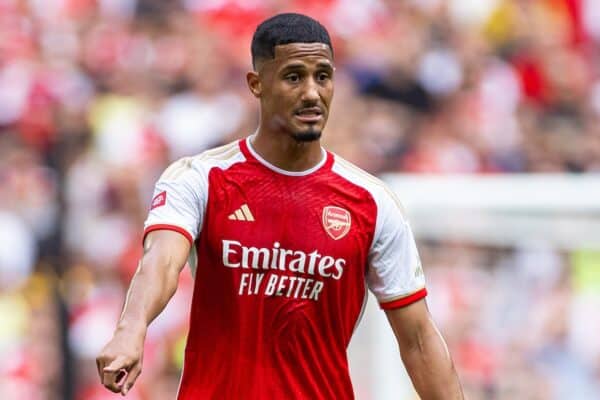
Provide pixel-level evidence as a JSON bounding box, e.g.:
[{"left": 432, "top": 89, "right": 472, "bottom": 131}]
[{"left": 0, "top": 0, "right": 600, "bottom": 400}]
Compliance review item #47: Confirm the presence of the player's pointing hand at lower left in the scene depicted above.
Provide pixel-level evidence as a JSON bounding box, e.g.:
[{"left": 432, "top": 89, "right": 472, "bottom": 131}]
[{"left": 96, "top": 330, "right": 145, "bottom": 396}]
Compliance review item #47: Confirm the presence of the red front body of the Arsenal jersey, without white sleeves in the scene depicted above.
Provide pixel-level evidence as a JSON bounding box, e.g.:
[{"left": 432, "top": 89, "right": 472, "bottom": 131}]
[{"left": 180, "top": 142, "right": 375, "bottom": 399}]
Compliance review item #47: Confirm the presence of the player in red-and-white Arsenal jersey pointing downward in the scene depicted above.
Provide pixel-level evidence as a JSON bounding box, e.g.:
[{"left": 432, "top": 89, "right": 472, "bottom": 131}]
[{"left": 97, "top": 14, "right": 462, "bottom": 400}]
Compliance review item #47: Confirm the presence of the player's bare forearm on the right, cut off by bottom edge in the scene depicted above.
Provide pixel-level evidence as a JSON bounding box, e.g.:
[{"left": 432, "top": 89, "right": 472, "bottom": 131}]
[{"left": 402, "top": 323, "right": 464, "bottom": 400}]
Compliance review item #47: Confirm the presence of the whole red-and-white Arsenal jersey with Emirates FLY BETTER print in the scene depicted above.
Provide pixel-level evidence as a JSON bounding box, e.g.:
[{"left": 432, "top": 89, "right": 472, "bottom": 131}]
[{"left": 144, "top": 138, "right": 427, "bottom": 400}]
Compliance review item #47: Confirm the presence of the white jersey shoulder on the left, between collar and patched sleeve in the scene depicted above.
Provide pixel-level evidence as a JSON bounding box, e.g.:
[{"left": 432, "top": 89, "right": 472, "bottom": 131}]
[{"left": 160, "top": 141, "right": 246, "bottom": 181}]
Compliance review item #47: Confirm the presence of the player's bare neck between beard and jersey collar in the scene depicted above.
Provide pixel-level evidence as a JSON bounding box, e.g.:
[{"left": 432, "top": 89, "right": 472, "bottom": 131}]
[{"left": 252, "top": 126, "right": 323, "bottom": 172}]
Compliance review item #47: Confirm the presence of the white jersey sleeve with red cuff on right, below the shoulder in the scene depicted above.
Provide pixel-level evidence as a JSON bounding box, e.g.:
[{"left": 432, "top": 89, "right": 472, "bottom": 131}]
[{"left": 367, "top": 188, "right": 427, "bottom": 309}]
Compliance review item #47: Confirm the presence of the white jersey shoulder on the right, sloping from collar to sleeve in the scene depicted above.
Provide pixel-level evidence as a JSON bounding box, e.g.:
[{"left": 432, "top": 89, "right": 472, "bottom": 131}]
[{"left": 331, "top": 154, "right": 404, "bottom": 215}]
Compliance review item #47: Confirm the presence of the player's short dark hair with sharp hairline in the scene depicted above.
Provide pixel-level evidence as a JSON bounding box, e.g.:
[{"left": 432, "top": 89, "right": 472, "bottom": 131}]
[{"left": 252, "top": 13, "right": 333, "bottom": 68}]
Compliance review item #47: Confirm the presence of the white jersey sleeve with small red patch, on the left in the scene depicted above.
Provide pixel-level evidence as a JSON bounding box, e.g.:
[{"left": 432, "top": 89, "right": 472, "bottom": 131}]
[{"left": 144, "top": 158, "right": 208, "bottom": 245}]
